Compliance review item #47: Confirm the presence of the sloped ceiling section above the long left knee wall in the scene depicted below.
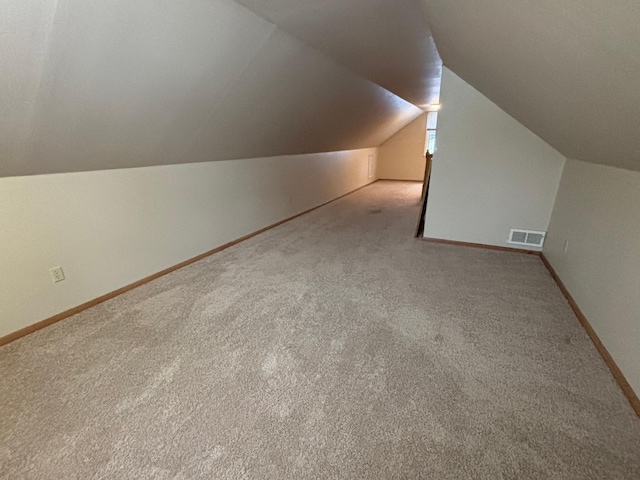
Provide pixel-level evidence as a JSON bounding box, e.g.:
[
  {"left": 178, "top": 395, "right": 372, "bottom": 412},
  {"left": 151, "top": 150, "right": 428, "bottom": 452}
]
[{"left": 0, "top": 0, "right": 428, "bottom": 176}]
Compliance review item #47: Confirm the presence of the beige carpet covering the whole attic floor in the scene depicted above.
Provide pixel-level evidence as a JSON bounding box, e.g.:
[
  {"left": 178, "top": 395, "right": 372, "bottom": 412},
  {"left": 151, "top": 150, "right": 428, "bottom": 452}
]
[{"left": 0, "top": 182, "right": 640, "bottom": 480}]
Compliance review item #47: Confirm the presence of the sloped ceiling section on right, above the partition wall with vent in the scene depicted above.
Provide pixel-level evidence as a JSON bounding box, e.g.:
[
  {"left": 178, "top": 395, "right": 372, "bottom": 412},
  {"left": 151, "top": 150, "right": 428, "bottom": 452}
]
[{"left": 422, "top": 0, "right": 640, "bottom": 170}]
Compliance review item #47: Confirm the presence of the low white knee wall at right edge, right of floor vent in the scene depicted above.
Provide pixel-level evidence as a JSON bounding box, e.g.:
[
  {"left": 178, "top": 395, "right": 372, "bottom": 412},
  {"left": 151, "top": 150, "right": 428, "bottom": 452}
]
[{"left": 544, "top": 160, "right": 640, "bottom": 393}]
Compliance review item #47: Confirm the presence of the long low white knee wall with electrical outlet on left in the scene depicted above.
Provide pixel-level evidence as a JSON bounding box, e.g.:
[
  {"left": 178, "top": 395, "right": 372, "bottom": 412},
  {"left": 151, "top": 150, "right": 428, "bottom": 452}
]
[{"left": 0, "top": 149, "right": 376, "bottom": 337}]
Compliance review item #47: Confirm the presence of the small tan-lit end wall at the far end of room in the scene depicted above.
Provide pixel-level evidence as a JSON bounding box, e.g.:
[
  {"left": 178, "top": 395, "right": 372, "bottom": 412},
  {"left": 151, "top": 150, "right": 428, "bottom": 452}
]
[{"left": 378, "top": 114, "right": 427, "bottom": 180}]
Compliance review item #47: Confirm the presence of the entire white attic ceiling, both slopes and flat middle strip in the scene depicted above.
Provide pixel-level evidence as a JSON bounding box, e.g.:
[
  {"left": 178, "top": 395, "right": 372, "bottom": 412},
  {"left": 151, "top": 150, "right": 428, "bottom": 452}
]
[{"left": 0, "top": 0, "right": 640, "bottom": 176}]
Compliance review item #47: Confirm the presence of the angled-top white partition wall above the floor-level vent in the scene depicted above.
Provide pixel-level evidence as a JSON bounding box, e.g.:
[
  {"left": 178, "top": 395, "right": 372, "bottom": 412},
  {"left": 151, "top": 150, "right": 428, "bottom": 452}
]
[{"left": 424, "top": 68, "right": 564, "bottom": 246}]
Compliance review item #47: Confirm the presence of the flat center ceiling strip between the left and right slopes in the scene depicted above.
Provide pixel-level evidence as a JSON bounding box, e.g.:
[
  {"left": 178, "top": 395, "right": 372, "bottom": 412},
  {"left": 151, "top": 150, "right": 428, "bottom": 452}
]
[{"left": 238, "top": 0, "right": 442, "bottom": 106}]
